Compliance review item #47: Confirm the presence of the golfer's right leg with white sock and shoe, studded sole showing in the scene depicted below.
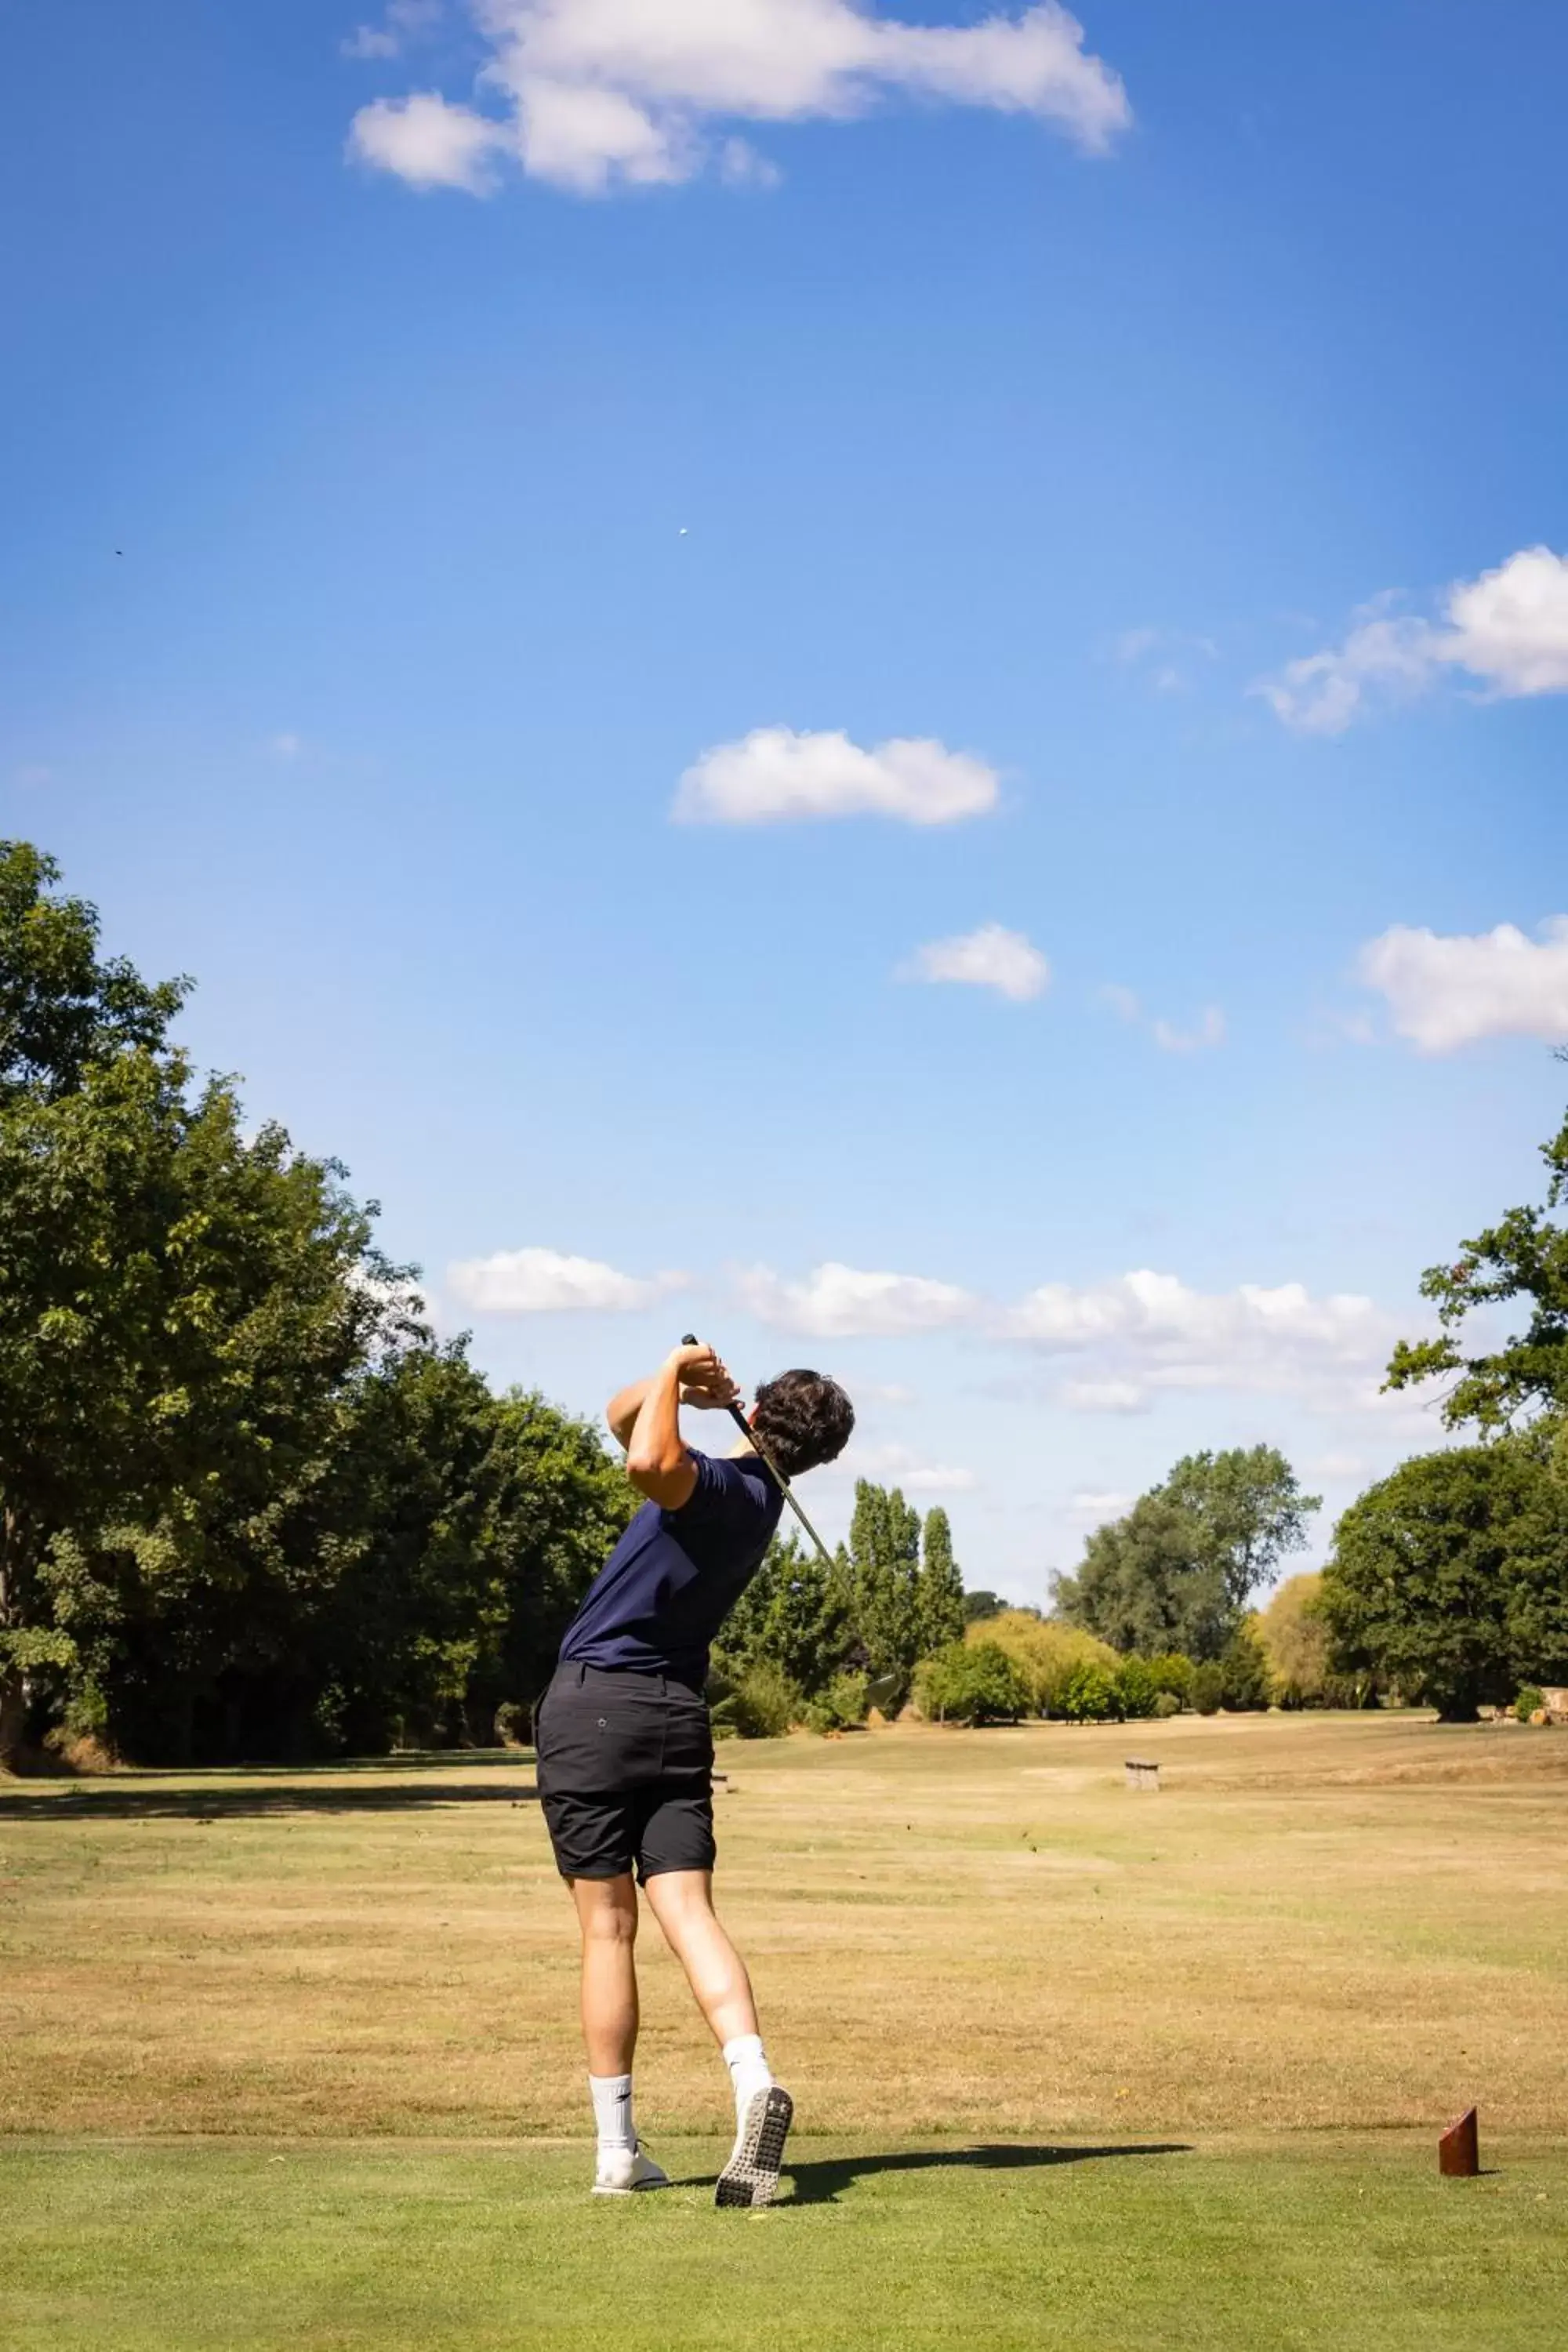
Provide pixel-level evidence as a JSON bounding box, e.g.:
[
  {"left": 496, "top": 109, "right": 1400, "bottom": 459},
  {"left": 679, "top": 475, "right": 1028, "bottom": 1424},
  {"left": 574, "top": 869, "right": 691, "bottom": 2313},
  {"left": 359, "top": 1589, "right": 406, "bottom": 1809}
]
[{"left": 644, "top": 1870, "right": 794, "bottom": 2206}]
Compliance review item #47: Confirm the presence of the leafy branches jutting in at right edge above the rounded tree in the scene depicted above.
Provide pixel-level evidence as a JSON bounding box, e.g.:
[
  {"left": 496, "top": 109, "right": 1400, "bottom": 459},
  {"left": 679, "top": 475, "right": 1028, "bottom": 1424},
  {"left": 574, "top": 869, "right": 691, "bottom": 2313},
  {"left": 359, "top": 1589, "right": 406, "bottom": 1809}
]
[{"left": 1385, "top": 1091, "right": 1568, "bottom": 1432}]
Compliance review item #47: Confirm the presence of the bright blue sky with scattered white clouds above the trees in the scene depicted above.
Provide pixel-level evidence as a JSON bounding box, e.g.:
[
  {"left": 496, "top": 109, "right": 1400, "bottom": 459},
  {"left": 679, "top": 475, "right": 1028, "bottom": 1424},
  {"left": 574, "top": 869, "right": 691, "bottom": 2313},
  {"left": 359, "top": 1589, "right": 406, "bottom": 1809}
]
[{"left": 0, "top": 0, "right": 1568, "bottom": 1599}]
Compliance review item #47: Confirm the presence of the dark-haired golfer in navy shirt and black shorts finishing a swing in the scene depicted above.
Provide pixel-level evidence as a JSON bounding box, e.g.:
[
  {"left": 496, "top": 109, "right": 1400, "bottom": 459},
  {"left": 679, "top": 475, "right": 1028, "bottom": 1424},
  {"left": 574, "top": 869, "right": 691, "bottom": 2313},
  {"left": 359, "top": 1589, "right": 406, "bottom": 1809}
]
[{"left": 536, "top": 1345, "right": 855, "bottom": 2206}]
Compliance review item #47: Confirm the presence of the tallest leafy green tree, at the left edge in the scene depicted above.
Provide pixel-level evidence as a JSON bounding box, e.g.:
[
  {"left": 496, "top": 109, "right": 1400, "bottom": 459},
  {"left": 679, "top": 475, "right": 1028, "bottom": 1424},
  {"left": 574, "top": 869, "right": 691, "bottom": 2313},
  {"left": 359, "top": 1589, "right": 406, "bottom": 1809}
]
[{"left": 0, "top": 844, "right": 407, "bottom": 1755}]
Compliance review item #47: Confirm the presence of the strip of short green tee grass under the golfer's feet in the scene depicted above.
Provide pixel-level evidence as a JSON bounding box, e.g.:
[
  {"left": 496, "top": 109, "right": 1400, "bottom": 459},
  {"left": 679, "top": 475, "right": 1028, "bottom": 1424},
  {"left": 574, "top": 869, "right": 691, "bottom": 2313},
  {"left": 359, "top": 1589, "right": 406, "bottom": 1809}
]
[{"left": 0, "top": 2138, "right": 1568, "bottom": 2352}]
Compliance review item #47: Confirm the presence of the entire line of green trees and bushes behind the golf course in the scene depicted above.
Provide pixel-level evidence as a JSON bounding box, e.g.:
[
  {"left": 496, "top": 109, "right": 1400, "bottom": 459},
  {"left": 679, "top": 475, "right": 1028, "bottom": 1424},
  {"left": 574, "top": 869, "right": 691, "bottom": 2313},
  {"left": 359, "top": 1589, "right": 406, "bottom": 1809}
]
[{"left": 0, "top": 842, "right": 1568, "bottom": 1762}]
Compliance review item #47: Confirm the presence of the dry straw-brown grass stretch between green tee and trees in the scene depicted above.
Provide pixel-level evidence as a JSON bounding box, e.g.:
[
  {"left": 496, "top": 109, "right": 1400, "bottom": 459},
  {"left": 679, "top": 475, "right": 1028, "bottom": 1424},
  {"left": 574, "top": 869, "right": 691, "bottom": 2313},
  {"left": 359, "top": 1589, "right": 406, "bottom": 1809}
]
[{"left": 0, "top": 1717, "right": 1568, "bottom": 2136}]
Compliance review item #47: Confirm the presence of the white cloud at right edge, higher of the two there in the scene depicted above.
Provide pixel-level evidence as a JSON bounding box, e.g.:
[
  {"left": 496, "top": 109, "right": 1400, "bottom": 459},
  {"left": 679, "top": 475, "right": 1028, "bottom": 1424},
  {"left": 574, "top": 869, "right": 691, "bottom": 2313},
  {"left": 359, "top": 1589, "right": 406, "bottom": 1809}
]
[{"left": 1253, "top": 548, "right": 1568, "bottom": 734}]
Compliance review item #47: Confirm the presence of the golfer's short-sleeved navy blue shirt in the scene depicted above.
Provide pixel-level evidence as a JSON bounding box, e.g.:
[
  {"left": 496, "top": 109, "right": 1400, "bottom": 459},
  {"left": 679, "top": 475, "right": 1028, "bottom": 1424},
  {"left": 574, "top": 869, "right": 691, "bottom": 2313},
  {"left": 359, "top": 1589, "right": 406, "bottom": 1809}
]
[{"left": 562, "top": 1446, "right": 783, "bottom": 1691}]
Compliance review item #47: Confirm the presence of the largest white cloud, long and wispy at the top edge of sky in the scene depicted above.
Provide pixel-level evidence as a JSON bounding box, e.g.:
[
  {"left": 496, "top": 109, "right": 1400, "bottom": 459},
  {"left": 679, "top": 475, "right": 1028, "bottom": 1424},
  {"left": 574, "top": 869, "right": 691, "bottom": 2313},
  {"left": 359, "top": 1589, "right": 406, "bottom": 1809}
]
[{"left": 360, "top": 0, "right": 1131, "bottom": 193}]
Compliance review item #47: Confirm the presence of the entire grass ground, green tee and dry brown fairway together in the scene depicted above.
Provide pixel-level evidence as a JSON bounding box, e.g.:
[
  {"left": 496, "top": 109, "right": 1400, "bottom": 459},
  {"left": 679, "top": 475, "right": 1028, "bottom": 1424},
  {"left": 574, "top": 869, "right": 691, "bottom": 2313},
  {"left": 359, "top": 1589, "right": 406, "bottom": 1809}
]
[{"left": 0, "top": 1715, "right": 1568, "bottom": 2352}]
